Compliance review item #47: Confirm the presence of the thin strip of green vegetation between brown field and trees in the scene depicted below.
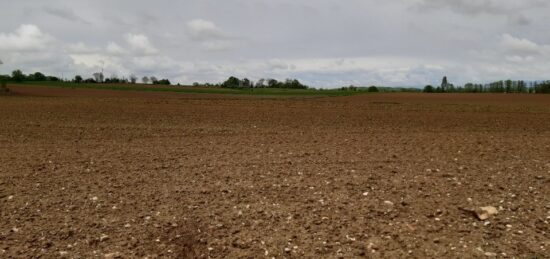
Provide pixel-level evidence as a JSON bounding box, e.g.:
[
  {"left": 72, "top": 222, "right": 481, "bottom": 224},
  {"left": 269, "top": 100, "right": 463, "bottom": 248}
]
[{"left": 15, "top": 81, "right": 366, "bottom": 96}]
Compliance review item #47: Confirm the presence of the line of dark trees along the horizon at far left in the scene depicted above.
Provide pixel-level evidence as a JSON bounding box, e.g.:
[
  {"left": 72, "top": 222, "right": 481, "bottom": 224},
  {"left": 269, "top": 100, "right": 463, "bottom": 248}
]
[{"left": 0, "top": 69, "right": 171, "bottom": 85}]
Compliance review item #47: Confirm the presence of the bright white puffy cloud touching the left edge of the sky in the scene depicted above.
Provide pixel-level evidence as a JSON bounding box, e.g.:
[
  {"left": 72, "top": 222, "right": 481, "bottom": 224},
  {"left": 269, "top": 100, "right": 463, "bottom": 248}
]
[{"left": 0, "top": 24, "right": 53, "bottom": 51}]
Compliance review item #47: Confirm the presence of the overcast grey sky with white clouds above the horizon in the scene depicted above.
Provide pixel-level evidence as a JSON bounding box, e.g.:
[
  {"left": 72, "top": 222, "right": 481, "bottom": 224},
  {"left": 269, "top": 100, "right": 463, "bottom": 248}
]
[{"left": 0, "top": 0, "right": 550, "bottom": 88}]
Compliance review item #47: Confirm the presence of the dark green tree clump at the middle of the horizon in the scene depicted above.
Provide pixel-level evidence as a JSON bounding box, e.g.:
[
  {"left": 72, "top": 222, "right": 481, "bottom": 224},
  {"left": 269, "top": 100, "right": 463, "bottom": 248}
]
[{"left": 219, "top": 76, "right": 309, "bottom": 89}]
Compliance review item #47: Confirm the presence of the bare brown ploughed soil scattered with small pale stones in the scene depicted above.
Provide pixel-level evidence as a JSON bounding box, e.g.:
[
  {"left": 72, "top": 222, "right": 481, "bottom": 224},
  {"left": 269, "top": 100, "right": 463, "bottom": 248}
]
[{"left": 0, "top": 87, "right": 550, "bottom": 258}]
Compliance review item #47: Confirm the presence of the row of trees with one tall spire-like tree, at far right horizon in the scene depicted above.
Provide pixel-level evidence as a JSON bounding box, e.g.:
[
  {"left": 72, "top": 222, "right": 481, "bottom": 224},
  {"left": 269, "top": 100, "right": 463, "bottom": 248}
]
[{"left": 424, "top": 77, "right": 550, "bottom": 93}]
